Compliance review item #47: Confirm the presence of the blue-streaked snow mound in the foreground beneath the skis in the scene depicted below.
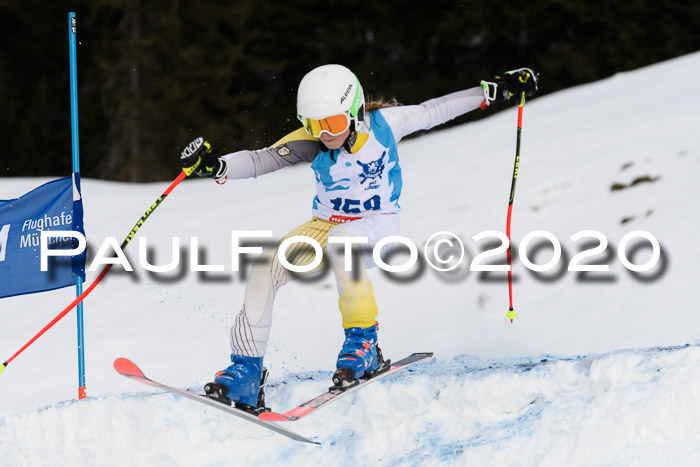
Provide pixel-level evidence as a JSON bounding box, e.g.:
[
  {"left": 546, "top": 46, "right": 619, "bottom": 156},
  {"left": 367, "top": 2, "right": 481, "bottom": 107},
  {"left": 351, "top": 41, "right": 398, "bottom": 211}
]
[{"left": 0, "top": 346, "right": 700, "bottom": 466}]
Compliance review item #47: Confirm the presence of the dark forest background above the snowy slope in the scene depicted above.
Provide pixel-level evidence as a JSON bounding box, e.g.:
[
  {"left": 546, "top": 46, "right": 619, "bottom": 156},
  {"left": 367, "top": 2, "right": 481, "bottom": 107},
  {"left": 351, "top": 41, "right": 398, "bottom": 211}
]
[{"left": 0, "top": 0, "right": 700, "bottom": 181}]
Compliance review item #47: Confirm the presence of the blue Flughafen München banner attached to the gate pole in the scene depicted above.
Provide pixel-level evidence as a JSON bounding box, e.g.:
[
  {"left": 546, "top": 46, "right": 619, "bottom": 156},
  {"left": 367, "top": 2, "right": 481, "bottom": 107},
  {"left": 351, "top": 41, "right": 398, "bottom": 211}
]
[{"left": 0, "top": 173, "right": 85, "bottom": 298}]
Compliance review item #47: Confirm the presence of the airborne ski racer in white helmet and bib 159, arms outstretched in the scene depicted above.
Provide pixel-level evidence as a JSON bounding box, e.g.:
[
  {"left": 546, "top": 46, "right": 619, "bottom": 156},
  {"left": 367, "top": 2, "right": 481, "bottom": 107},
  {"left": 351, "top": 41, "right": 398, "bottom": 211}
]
[{"left": 181, "top": 65, "right": 537, "bottom": 411}]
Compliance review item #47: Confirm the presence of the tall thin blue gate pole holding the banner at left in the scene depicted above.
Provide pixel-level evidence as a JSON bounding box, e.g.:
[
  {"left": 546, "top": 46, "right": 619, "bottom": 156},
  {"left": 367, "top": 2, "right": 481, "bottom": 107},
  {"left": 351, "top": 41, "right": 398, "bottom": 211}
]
[{"left": 68, "top": 12, "right": 86, "bottom": 399}]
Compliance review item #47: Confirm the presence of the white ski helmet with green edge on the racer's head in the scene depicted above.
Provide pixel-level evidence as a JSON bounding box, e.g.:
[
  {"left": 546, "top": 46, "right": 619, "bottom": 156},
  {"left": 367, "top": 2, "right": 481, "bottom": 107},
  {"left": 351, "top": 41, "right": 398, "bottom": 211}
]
[{"left": 297, "top": 65, "right": 365, "bottom": 137}]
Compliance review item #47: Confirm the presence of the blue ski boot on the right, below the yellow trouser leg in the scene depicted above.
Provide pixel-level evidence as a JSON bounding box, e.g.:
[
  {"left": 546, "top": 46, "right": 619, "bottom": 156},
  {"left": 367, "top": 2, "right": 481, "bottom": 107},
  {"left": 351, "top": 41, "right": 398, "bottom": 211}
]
[{"left": 333, "top": 324, "right": 384, "bottom": 388}]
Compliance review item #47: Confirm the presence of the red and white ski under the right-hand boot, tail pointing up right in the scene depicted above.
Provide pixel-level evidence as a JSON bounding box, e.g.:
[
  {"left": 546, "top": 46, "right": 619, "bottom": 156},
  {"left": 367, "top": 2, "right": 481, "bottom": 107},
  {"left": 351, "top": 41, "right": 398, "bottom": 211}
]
[{"left": 258, "top": 352, "right": 433, "bottom": 422}]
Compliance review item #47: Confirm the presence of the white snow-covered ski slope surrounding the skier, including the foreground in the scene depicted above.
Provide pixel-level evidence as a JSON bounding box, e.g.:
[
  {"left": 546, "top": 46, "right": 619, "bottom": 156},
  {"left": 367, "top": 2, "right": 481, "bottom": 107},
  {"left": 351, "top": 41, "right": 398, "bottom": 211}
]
[{"left": 0, "top": 53, "right": 700, "bottom": 465}]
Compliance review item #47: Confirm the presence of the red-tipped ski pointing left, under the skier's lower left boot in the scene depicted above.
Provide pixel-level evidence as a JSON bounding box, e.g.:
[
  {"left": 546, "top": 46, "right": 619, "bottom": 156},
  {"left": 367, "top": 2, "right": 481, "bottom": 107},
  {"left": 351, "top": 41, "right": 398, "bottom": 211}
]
[{"left": 114, "top": 358, "right": 321, "bottom": 444}]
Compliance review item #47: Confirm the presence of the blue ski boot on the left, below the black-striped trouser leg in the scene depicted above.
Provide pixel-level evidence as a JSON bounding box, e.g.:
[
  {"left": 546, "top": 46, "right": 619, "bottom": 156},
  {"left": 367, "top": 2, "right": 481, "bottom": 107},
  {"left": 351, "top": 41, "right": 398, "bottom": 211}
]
[{"left": 204, "top": 354, "right": 267, "bottom": 412}]
